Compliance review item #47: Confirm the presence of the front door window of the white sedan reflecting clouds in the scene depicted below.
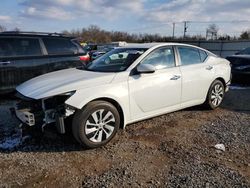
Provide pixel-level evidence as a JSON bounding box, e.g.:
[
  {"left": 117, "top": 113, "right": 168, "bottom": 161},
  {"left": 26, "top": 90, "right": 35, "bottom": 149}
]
[{"left": 141, "top": 47, "right": 175, "bottom": 69}]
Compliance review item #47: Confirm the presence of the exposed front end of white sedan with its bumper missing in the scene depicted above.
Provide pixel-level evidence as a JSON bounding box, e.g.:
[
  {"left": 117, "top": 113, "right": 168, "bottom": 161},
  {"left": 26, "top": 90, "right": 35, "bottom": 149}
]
[{"left": 10, "top": 91, "right": 75, "bottom": 134}]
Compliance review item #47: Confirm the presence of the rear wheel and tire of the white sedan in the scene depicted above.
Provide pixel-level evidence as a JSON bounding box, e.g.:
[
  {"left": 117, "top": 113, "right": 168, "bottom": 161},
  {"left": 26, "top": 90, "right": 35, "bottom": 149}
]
[{"left": 205, "top": 80, "right": 225, "bottom": 110}]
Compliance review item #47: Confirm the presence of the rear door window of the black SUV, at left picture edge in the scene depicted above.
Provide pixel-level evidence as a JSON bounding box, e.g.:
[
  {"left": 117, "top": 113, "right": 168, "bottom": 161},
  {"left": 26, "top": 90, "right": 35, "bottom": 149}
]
[{"left": 0, "top": 37, "right": 42, "bottom": 57}]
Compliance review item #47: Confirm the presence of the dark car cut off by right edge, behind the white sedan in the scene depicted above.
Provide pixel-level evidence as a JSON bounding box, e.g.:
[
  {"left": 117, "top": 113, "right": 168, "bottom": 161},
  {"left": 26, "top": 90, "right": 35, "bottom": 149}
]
[{"left": 226, "top": 47, "right": 250, "bottom": 84}]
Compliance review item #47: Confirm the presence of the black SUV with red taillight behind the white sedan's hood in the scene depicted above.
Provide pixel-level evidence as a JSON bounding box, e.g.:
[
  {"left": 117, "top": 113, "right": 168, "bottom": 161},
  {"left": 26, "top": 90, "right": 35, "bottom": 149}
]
[{"left": 0, "top": 32, "right": 86, "bottom": 94}]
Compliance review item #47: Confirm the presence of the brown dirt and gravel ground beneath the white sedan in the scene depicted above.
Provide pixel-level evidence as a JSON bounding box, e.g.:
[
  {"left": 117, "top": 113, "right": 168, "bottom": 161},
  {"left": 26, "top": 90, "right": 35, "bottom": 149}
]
[{"left": 0, "top": 88, "right": 250, "bottom": 188}]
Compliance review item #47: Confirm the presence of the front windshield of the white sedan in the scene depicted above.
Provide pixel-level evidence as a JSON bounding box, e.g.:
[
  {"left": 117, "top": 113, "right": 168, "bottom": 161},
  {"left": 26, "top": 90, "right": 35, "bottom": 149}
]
[{"left": 86, "top": 48, "right": 147, "bottom": 72}]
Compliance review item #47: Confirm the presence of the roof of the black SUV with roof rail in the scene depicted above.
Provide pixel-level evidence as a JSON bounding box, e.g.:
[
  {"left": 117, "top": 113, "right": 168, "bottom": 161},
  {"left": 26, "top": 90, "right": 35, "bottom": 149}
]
[{"left": 0, "top": 31, "right": 74, "bottom": 39}]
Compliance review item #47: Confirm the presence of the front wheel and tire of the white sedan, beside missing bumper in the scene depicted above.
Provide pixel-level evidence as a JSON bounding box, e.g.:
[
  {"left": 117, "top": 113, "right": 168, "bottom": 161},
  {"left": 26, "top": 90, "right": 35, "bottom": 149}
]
[{"left": 72, "top": 101, "right": 120, "bottom": 148}]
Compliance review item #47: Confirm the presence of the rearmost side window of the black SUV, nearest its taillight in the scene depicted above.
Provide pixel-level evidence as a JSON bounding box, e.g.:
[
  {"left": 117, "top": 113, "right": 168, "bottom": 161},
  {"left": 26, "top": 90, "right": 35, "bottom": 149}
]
[{"left": 43, "top": 38, "right": 78, "bottom": 55}]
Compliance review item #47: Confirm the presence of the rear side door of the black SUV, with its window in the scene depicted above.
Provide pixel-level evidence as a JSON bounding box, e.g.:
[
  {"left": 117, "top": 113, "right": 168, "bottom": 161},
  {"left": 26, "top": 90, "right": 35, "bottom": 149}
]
[{"left": 0, "top": 36, "right": 48, "bottom": 93}]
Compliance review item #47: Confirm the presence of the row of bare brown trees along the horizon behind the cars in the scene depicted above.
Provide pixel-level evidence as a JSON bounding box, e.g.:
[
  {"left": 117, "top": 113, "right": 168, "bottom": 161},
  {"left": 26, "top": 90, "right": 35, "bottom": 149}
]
[{"left": 62, "top": 24, "right": 250, "bottom": 44}]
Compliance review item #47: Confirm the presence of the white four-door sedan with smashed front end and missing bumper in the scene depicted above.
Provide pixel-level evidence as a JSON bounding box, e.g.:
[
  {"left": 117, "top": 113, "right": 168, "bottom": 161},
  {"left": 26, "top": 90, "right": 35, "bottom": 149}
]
[{"left": 15, "top": 43, "right": 231, "bottom": 148}]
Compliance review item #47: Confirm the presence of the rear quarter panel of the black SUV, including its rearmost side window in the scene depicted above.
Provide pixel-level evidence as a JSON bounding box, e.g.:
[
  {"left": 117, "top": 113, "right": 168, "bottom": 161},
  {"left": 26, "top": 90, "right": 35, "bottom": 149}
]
[{"left": 43, "top": 37, "right": 85, "bottom": 71}]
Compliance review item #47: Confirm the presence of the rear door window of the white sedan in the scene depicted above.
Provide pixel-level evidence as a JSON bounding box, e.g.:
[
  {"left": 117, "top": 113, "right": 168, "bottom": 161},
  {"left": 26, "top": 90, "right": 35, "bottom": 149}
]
[{"left": 178, "top": 47, "right": 202, "bottom": 65}]
